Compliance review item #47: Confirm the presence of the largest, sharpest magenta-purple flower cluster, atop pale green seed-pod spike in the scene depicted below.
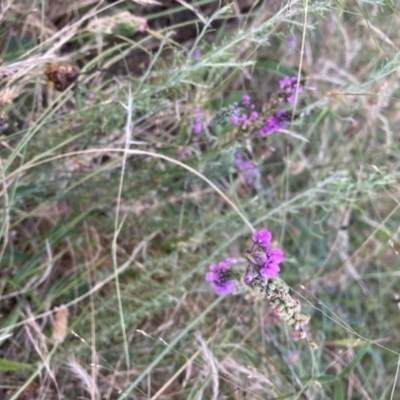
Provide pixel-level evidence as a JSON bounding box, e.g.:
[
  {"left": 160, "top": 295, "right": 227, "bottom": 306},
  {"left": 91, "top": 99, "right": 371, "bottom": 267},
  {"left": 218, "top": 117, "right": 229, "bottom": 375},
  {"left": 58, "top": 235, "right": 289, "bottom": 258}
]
[{"left": 205, "top": 229, "right": 284, "bottom": 295}]
